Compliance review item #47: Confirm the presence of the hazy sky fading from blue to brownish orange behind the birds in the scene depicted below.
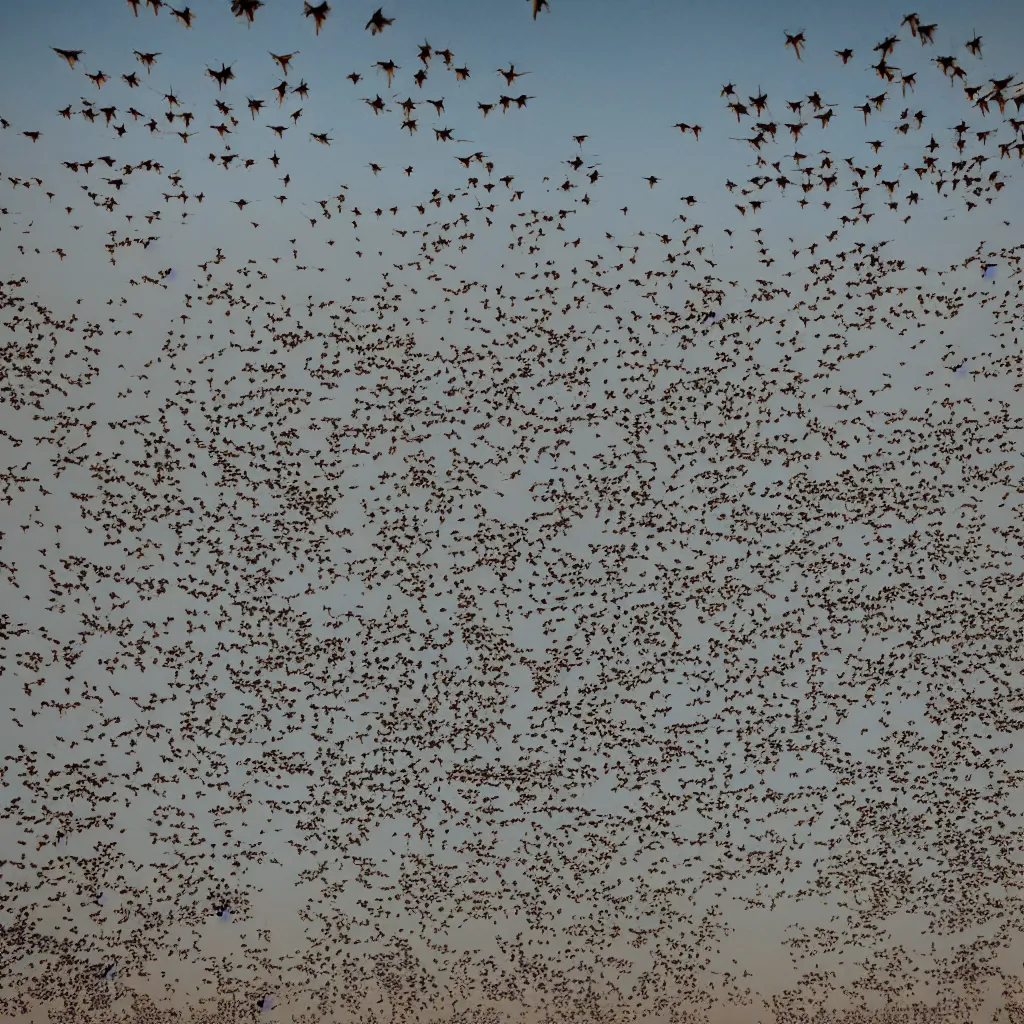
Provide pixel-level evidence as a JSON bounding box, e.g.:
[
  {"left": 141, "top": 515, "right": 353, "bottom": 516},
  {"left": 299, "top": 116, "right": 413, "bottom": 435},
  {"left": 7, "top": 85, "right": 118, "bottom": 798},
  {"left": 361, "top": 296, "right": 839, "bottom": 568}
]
[{"left": 0, "top": 0, "right": 1024, "bottom": 1021}]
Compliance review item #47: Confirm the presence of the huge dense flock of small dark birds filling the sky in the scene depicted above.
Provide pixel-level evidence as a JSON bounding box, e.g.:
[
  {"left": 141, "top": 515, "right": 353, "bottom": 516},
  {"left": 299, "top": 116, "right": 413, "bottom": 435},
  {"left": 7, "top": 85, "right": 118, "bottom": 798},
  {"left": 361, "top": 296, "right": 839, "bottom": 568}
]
[{"left": 0, "top": 0, "right": 1024, "bottom": 1022}]
